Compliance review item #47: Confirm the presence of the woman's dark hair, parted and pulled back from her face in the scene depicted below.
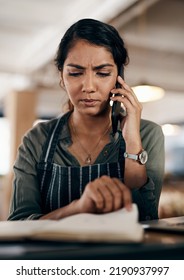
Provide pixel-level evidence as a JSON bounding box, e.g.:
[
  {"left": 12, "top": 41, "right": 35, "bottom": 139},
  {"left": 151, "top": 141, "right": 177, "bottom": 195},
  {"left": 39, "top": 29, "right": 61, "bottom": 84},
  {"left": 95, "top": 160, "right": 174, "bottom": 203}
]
[{"left": 55, "top": 19, "right": 129, "bottom": 73}]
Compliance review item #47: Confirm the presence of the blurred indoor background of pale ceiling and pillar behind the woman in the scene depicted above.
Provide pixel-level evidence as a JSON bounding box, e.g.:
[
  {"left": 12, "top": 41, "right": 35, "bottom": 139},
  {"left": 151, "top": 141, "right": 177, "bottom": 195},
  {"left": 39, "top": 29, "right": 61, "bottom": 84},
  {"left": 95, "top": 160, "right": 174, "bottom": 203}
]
[{"left": 0, "top": 0, "right": 184, "bottom": 220}]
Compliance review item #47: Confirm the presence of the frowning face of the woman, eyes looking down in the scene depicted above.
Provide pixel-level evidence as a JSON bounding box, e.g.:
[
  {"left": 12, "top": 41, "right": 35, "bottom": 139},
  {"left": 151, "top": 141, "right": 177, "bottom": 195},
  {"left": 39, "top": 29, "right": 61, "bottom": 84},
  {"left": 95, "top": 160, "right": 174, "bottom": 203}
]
[{"left": 61, "top": 40, "right": 118, "bottom": 115}]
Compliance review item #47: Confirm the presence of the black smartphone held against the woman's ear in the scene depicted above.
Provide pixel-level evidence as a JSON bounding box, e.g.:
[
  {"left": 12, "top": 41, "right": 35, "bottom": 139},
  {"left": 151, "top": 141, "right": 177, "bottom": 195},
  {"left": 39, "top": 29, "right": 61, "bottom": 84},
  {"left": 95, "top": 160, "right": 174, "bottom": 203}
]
[{"left": 111, "top": 67, "right": 124, "bottom": 135}]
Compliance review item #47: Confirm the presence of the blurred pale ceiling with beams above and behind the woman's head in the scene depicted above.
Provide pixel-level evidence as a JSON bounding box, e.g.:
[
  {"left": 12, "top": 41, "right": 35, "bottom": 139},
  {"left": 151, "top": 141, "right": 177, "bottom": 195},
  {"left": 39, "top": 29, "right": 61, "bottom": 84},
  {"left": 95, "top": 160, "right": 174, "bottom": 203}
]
[{"left": 0, "top": 0, "right": 184, "bottom": 124}]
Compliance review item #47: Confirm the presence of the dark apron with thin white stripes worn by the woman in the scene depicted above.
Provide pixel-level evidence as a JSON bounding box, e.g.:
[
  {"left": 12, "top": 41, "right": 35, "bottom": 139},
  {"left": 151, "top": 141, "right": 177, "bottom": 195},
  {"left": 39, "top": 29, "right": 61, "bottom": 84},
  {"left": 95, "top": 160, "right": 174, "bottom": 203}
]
[{"left": 38, "top": 115, "right": 125, "bottom": 213}]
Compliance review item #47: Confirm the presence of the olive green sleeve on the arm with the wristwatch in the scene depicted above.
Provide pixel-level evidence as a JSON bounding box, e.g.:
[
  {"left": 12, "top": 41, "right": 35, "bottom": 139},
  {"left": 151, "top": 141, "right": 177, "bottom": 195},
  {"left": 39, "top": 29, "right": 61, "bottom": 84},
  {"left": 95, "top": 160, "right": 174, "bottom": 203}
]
[{"left": 132, "top": 121, "right": 165, "bottom": 221}]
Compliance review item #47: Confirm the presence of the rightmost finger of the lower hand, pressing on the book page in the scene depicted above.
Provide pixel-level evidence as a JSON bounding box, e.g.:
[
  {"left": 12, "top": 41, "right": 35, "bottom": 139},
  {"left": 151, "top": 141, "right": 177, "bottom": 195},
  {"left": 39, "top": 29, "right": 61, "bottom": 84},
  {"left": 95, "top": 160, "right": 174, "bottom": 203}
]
[{"left": 113, "top": 178, "right": 132, "bottom": 210}]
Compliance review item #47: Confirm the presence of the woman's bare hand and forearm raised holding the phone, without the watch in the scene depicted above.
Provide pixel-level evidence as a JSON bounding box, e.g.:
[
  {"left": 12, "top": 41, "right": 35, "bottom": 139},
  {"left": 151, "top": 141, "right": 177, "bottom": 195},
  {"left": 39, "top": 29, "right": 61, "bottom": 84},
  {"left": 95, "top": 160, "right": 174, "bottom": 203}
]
[{"left": 111, "top": 76, "right": 147, "bottom": 188}]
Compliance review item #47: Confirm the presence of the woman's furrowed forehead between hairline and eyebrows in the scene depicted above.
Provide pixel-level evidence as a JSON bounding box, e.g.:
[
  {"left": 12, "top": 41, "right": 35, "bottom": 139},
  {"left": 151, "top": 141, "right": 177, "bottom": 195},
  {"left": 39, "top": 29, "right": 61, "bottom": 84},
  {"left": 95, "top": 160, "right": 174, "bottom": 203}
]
[{"left": 65, "top": 40, "right": 115, "bottom": 65}]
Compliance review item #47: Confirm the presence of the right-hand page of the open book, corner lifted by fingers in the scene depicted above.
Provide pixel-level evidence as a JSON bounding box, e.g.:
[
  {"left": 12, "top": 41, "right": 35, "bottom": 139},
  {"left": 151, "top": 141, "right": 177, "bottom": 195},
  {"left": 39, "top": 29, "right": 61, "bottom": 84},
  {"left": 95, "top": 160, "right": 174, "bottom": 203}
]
[{"left": 34, "top": 204, "right": 143, "bottom": 242}]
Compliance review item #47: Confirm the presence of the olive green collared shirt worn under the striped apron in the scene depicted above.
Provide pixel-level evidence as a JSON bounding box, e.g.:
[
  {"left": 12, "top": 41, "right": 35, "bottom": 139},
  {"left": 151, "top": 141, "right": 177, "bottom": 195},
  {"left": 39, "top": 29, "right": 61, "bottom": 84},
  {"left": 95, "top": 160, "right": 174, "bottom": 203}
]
[{"left": 8, "top": 115, "right": 165, "bottom": 220}]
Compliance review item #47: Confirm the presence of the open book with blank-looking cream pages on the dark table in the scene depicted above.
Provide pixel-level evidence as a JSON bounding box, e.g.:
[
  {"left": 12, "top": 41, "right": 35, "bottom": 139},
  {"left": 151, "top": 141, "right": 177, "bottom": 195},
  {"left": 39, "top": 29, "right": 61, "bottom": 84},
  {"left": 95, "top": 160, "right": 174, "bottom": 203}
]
[{"left": 0, "top": 204, "right": 143, "bottom": 242}]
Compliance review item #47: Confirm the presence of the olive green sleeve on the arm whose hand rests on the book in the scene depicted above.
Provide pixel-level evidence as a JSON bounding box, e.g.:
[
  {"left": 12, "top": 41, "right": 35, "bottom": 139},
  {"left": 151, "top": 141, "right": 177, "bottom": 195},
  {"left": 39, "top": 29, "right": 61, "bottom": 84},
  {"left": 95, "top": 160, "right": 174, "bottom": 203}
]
[{"left": 8, "top": 122, "right": 48, "bottom": 220}]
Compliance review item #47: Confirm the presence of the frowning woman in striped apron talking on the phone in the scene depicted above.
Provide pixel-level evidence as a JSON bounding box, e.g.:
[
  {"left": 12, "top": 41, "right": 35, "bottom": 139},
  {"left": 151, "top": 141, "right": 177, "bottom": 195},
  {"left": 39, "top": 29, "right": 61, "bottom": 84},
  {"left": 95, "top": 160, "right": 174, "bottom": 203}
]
[{"left": 8, "top": 19, "right": 164, "bottom": 220}]
